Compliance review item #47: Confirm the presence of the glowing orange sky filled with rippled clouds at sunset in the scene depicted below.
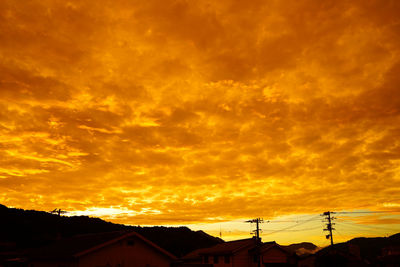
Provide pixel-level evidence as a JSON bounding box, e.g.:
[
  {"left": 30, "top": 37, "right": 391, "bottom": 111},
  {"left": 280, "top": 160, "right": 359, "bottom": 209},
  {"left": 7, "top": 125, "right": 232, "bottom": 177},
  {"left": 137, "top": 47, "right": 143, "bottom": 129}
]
[{"left": 0, "top": 0, "right": 400, "bottom": 247}]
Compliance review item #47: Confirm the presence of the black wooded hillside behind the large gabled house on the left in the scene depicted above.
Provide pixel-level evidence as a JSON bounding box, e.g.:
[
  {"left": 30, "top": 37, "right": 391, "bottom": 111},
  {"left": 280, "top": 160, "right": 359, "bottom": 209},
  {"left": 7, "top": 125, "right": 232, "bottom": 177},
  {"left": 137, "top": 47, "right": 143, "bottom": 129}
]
[{"left": 0, "top": 204, "right": 222, "bottom": 257}]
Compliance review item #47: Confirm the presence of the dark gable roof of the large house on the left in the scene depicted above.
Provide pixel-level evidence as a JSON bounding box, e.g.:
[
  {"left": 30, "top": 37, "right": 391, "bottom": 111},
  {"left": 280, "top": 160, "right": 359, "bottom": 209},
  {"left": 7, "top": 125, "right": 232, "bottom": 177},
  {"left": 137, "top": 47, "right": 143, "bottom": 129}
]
[{"left": 28, "top": 231, "right": 176, "bottom": 260}]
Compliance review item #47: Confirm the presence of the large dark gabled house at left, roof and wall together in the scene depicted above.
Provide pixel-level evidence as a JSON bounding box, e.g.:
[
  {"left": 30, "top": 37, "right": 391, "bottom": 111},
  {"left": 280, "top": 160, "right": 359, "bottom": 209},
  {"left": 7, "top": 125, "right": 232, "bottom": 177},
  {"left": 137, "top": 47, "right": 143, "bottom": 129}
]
[{"left": 14, "top": 231, "right": 176, "bottom": 267}]
